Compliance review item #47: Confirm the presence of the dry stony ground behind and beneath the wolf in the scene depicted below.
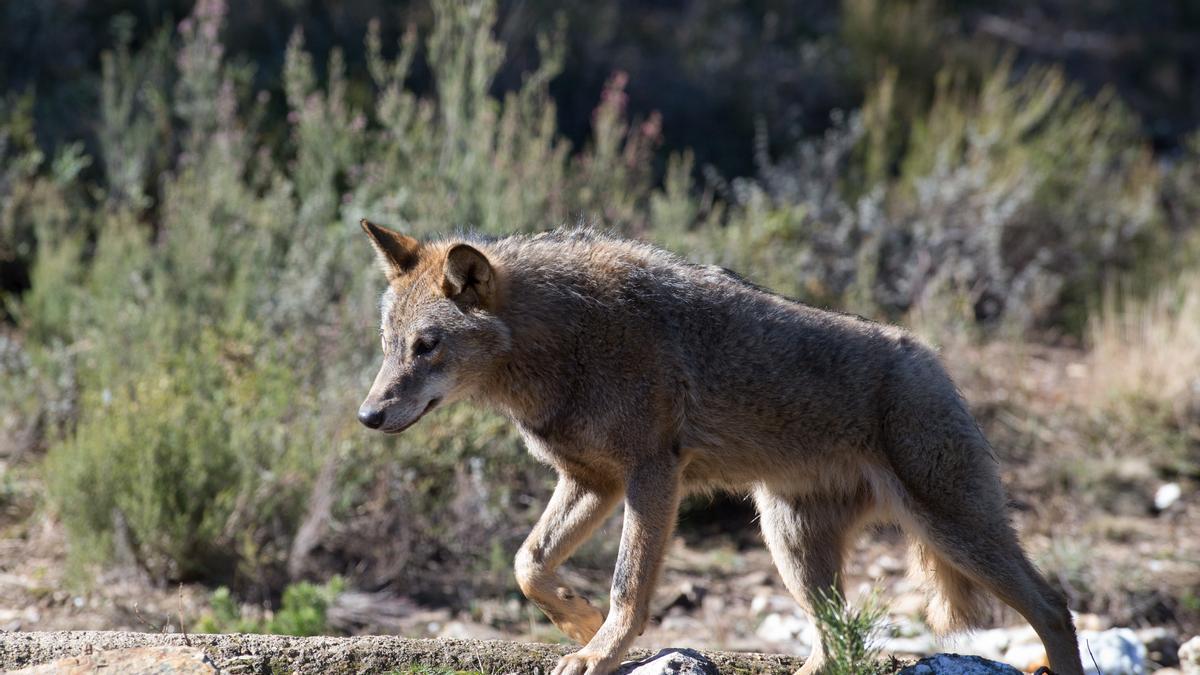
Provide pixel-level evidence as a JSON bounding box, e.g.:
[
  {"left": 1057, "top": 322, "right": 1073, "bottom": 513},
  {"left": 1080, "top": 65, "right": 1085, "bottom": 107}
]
[{"left": 0, "top": 343, "right": 1200, "bottom": 675}]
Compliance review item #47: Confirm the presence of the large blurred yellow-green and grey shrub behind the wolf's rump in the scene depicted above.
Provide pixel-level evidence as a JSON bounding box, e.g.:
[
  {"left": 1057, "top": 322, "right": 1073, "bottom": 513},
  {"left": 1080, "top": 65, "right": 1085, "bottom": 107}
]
[{"left": 672, "top": 53, "right": 1165, "bottom": 334}]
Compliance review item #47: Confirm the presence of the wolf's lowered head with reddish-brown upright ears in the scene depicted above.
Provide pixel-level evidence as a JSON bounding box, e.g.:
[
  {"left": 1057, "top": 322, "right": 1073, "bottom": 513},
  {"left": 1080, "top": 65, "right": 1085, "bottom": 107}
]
[{"left": 359, "top": 220, "right": 510, "bottom": 434}]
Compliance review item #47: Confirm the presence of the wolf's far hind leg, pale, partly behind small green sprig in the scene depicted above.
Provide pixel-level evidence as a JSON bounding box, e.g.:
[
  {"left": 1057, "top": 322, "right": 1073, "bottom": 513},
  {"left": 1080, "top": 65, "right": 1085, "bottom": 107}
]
[{"left": 754, "top": 488, "right": 869, "bottom": 675}]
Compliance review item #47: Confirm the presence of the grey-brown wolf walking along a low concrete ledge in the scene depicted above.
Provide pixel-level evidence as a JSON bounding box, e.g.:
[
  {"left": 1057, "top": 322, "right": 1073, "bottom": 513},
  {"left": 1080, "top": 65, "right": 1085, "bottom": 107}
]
[{"left": 358, "top": 221, "right": 1084, "bottom": 675}]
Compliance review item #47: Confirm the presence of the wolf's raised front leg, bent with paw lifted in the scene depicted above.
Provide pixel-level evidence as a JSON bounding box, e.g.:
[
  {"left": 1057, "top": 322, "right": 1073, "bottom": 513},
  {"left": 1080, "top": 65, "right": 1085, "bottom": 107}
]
[{"left": 516, "top": 474, "right": 622, "bottom": 644}]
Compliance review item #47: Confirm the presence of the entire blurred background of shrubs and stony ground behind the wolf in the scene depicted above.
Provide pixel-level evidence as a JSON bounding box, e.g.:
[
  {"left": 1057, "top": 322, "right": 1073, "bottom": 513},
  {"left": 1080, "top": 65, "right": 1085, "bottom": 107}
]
[{"left": 0, "top": 0, "right": 1200, "bottom": 670}]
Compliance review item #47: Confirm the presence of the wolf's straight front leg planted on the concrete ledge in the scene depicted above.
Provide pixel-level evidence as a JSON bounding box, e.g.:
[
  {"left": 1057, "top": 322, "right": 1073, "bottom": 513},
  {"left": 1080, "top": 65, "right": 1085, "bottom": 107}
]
[{"left": 553, "top": 454, "right": 680, "bottom": 675}]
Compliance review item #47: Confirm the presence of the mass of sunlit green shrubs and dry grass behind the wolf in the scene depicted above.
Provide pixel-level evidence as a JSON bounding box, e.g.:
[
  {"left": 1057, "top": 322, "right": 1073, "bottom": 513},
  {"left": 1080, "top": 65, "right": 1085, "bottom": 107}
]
[{"left": 0, "top": 0, "right": 1200, "bottom": 634}]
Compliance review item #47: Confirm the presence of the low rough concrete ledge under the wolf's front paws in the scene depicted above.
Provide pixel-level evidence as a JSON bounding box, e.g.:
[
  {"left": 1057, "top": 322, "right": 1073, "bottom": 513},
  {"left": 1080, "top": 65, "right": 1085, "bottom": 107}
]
[{"left": 0, "top": 631, "right": 802, "bottom": 675}]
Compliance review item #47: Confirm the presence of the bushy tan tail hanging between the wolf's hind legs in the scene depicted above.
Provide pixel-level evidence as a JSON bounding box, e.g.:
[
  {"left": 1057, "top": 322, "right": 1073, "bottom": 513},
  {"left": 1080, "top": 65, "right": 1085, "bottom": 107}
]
[{"left": 908, "top": 537, "right": 992, "bottom": 635}]
